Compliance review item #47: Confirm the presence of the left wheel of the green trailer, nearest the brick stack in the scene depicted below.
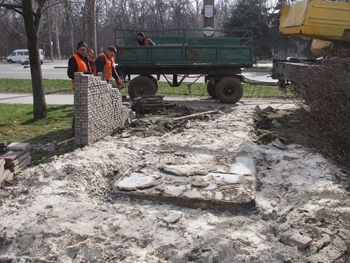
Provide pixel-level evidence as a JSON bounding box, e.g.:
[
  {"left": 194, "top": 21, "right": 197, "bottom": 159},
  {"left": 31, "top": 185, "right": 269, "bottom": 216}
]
[{"left": 128, "top": 76, "right": 157, "bottom": 99}]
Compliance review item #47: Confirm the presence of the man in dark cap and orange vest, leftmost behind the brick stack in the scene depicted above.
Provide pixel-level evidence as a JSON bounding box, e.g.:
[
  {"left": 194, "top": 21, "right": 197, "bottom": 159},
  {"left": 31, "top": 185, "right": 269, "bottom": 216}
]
[{"left": 67, "top": 41, "right": 92, "bottom": 89}]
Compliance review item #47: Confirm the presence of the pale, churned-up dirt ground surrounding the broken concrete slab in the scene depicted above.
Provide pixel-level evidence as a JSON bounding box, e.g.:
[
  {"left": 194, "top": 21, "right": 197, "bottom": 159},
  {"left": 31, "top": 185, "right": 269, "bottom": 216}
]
[{"left": 0, "top": 101, "right": 350, "bottom": 263}]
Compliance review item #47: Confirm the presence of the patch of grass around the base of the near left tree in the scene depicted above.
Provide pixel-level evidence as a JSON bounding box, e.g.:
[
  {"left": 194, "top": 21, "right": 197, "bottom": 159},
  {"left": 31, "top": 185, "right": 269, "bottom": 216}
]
[{"left": 0, "top": 104, "right": 74, "bottom": 164}]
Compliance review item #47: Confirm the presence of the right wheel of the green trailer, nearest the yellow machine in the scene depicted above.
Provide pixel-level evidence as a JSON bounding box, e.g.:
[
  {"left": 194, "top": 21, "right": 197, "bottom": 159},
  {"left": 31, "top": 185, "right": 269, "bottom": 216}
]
[{"left": 215, "top": 77, "right": 243, "bottom": 103}]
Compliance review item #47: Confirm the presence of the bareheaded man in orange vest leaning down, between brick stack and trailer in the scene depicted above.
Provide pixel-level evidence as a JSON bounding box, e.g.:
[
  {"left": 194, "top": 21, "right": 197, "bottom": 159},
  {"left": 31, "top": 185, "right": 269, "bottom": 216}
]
[{"left": 94, "top": 46, "right": 123, "bottom": 86}]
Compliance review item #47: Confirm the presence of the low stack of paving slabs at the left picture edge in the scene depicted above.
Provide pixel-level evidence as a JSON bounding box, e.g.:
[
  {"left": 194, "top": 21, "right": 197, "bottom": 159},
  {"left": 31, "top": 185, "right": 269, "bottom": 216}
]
[{"left": 0, "top": 141, "right": 31, "bottom": 183}]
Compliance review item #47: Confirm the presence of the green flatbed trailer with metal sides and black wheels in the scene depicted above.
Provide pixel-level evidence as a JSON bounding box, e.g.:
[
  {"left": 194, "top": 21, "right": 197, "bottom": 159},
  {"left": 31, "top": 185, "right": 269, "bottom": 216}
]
[{"left": 115, "top": 29, "right": 253, "bottom": 103}]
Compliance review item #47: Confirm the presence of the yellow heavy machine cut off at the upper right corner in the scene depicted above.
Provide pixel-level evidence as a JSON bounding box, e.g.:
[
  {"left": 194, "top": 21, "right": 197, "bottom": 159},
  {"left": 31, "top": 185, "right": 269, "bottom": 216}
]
[{"left": 271, "top": 0, "right": 350, "bottom": 90}]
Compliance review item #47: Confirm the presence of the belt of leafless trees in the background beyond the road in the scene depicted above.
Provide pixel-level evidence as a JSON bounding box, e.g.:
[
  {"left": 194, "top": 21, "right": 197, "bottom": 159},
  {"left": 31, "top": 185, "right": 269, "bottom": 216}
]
[{"left": 0, "top": 0, "right": 270, "bottom": 62}]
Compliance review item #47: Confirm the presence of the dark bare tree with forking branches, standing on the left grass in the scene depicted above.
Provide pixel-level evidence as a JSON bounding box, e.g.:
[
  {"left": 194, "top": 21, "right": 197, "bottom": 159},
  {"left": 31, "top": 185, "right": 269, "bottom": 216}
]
[{"left": 0, "top": 0, "right": 47, "bottom": 119}]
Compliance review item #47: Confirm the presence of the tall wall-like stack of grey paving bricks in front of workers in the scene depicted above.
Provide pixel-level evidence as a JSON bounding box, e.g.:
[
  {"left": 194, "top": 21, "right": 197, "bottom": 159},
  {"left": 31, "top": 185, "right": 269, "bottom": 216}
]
[{"left": 74, "top": 72, "right": 131, "bottom": 146}]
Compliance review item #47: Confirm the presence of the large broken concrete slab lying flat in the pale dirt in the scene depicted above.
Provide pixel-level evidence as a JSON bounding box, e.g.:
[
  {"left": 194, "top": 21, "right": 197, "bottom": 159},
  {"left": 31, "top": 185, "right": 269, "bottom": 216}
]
[{"left": 114, "top": 156, "right": 256, "bottom": 212}]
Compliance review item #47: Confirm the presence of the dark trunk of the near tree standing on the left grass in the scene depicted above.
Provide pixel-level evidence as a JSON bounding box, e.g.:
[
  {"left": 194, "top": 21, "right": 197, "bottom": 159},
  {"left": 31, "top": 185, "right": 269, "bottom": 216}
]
[{"left": 22, "top": 0, "right": 47, "bottom": 119}]
